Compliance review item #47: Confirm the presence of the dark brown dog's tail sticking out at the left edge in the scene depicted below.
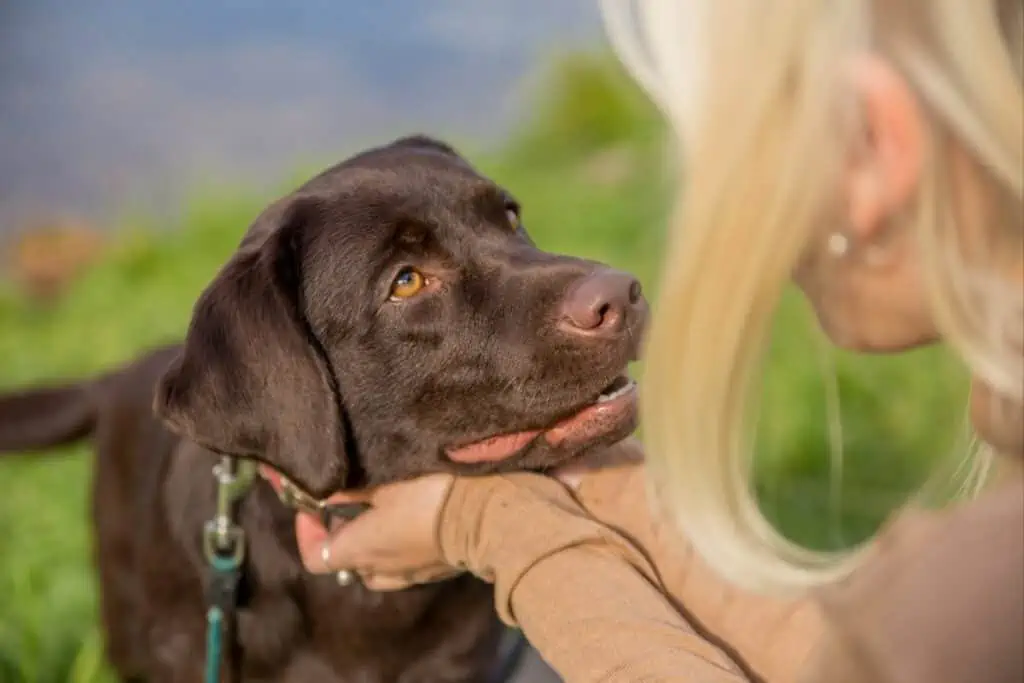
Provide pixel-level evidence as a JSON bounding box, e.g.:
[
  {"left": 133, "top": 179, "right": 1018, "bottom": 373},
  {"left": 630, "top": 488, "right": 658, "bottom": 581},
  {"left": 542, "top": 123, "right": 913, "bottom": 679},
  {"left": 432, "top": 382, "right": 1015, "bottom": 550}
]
[{"left": 0, "top": 380, "right": 98, "bottom": 453}]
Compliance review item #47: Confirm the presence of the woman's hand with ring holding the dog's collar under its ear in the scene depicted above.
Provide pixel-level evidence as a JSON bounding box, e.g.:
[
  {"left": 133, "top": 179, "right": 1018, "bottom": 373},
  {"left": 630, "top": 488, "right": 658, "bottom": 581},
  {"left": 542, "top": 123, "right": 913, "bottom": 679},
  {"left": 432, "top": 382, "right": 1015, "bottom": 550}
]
[{"left": 295, "top": 474, "right": 460, "bottom": 591}]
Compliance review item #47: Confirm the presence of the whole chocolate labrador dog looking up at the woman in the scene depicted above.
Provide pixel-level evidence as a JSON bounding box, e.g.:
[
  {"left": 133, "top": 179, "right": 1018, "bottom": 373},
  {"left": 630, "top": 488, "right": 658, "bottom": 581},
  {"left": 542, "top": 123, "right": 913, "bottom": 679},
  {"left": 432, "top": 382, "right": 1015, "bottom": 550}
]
[{"left": 0, "top": 136, "right": 646, "bottom": 683}]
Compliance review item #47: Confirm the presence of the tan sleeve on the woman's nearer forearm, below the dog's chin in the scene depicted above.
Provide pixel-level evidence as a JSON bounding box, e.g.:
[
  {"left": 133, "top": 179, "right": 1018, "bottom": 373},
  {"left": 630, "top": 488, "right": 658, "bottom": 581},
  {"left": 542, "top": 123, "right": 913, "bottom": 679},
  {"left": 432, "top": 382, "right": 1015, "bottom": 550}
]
[{"left": 440, "top": 474, "right": 748, "bottom": 683}]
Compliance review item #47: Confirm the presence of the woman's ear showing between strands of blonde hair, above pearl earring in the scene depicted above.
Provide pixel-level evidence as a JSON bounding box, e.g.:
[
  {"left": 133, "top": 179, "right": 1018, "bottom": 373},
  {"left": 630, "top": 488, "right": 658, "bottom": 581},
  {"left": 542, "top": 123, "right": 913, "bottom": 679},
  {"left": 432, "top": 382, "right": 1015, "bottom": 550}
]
[{"left": 845, "top": 54, "right": 926, "bottom": 243}]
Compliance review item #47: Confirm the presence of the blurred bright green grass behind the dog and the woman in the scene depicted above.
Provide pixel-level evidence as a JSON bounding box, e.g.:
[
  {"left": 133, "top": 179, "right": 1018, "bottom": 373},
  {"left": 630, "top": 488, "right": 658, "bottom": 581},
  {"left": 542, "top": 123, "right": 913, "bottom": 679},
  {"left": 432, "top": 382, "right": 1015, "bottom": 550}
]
[{"left": 0, "top": 56, "right": 966, "bottom": 683}]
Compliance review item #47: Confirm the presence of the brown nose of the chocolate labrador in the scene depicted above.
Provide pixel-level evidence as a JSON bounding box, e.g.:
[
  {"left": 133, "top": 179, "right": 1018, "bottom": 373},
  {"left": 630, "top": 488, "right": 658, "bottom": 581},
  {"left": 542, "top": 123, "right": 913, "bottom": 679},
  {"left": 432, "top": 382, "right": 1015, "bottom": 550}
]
[{"left": 562, "top": 269, "right": 641, "bottom": 336}]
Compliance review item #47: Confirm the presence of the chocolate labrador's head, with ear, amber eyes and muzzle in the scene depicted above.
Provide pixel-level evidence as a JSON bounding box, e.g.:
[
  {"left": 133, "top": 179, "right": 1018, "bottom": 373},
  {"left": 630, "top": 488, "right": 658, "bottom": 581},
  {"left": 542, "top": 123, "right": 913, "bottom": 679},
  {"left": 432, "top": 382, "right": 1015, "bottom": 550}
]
[{"left": 156, "top": 137, "right": 646, "bottom": 496}]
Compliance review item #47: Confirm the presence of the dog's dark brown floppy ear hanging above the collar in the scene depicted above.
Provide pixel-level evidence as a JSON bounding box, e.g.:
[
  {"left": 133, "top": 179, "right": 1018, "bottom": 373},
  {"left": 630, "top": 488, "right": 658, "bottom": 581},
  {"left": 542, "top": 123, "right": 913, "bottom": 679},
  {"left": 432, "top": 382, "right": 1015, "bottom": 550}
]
[{"left": 155, "top": 198, "right": 347, "bottom": 497}]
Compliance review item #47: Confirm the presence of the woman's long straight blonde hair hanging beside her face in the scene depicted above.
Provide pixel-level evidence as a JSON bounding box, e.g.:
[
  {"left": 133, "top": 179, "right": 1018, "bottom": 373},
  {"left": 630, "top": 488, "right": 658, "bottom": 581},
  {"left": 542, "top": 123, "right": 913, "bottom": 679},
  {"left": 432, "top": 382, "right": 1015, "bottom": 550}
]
[{"left": 602, "top": 0, "right": 1024, "bottom": 594}]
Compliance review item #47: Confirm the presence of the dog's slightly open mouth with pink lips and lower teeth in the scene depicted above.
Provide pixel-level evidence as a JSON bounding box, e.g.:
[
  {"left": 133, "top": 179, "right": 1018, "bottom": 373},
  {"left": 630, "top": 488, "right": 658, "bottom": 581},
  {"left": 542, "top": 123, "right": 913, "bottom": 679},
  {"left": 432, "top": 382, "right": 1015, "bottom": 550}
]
[{"left": 444, "top": 375, "right": 637, "bottom": 464}]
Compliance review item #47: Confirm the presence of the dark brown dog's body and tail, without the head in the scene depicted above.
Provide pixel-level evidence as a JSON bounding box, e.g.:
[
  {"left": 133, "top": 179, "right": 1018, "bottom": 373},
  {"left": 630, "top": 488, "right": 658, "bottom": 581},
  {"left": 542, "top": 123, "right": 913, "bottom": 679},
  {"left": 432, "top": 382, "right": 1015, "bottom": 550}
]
[{"left": 0, "top": 346, "right": 501, "bottom": 683}]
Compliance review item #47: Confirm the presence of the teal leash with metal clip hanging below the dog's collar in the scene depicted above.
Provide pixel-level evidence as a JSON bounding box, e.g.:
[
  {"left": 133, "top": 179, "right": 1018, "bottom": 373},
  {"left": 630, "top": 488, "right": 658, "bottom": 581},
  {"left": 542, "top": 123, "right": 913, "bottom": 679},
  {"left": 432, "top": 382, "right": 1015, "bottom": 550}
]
[{"left": 203, "top": 456, "right": 256, "bottom": 683}]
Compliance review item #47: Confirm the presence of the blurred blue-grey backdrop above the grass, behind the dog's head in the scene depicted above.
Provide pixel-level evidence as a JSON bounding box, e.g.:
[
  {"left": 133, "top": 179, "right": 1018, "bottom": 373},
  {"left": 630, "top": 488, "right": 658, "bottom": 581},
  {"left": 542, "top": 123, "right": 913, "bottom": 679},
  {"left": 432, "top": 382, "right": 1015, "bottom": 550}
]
[{"left": 0, "top": 0, "right": 603, "bottom": 230}]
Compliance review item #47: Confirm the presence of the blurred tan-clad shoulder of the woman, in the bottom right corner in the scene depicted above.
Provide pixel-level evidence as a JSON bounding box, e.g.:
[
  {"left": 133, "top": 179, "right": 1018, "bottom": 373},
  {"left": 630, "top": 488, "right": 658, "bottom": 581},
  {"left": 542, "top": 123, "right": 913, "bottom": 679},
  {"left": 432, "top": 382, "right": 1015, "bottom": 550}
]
[{"left": 800, "top": 482, "right": 1024, "bottom": 683}]
